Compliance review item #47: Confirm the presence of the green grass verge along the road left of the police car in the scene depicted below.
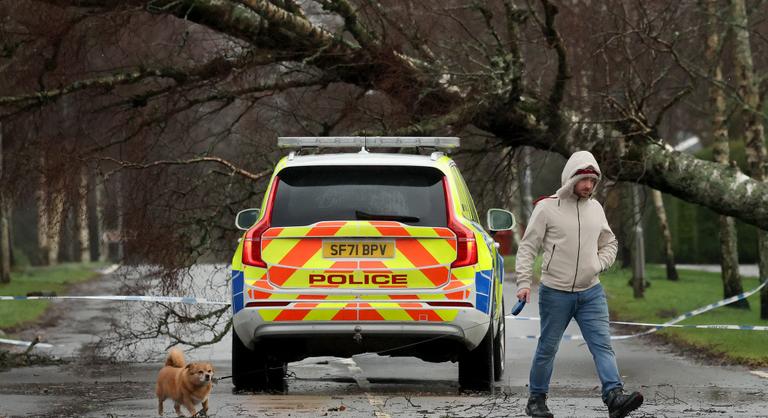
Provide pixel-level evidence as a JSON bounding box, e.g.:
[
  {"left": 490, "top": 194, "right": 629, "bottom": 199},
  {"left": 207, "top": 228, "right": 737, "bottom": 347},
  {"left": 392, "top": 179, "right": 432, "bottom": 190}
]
[{"left": 0, "top": 263, "right": 102, "bottom": 329}]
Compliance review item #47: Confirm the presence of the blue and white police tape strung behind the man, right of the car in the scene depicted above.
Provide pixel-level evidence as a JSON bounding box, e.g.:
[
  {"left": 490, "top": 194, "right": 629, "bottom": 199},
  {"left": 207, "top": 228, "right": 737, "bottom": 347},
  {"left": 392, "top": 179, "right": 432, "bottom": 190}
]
[{"left": 505, "top": 281, "right": 768, "bottom": 341}]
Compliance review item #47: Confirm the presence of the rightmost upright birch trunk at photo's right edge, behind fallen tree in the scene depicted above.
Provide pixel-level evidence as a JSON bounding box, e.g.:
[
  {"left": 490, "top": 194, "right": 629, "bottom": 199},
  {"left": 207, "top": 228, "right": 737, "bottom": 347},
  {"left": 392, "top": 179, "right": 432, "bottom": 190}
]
[{"left": 730, "top": 0, "right": 768, "bottom": 319}]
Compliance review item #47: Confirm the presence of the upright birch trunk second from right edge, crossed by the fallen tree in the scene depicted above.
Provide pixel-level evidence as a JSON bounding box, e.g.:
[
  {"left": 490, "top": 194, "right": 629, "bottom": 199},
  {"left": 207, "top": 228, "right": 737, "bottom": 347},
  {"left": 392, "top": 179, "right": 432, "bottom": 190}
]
[{"left": 704, "top": 0, "right": 749, "bottom": 309}]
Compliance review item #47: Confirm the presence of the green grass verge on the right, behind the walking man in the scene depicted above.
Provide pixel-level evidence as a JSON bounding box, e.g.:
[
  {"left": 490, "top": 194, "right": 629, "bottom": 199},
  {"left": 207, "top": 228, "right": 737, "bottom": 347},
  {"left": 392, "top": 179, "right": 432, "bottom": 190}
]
[{"left": 601, "top": 265, "right": 768, "bottom": 366}]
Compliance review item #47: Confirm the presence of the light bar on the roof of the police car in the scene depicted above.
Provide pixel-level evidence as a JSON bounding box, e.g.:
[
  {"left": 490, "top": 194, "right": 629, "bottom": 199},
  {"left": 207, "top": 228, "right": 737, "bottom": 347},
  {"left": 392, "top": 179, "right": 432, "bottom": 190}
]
[{"left": 277, "top": 136, "right": 459, "bottom": 149}]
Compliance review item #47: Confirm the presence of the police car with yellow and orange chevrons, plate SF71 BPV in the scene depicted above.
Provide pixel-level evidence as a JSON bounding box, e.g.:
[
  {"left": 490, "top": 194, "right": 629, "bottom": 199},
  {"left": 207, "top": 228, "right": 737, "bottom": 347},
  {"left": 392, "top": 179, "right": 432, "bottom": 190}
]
[{"left": 232, "top": 137, "right": 514, "bottom": 390}]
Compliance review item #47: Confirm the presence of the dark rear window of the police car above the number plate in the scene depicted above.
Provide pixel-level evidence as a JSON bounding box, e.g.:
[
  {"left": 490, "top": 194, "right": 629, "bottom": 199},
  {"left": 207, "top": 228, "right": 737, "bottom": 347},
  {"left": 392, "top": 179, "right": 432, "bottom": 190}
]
[{"left": 272, "top": 166, "right": 447, "bottom": 227}]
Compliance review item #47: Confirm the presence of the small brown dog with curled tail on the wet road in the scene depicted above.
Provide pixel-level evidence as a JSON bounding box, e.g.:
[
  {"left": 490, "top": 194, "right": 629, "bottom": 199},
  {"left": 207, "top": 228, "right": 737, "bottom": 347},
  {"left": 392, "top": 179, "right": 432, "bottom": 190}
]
[{"left": 157, "top": 348, "right": 213, "bottom": 416}]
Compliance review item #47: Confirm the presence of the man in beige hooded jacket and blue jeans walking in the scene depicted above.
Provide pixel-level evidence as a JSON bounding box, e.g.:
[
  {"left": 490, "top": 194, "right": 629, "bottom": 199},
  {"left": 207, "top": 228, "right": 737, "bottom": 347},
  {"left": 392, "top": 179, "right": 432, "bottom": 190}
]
[{"left": 515, "top": 151, "right": 643, "bottom": 418}]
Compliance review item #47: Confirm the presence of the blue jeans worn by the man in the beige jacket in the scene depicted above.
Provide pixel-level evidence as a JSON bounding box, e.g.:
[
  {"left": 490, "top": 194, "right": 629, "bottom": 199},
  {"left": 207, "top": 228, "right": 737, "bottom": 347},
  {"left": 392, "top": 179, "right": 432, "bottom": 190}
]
[{"left": 529, "top": 284, "right": 623, "bottom": 401}]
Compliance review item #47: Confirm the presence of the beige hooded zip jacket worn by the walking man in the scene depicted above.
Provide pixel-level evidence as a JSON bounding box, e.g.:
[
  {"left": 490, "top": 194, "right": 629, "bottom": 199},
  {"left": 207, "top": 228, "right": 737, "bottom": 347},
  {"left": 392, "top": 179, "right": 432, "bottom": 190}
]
[{"left": 515, "top": 151, "right": 618, "bottom": 292}]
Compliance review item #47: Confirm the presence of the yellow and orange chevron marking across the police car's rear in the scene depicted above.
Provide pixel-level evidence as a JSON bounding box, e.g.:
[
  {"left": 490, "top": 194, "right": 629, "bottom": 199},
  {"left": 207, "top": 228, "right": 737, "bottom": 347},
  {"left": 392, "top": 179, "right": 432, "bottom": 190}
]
[{"left": 244, "top": 221, "right": 475, "bottom": 322}]
